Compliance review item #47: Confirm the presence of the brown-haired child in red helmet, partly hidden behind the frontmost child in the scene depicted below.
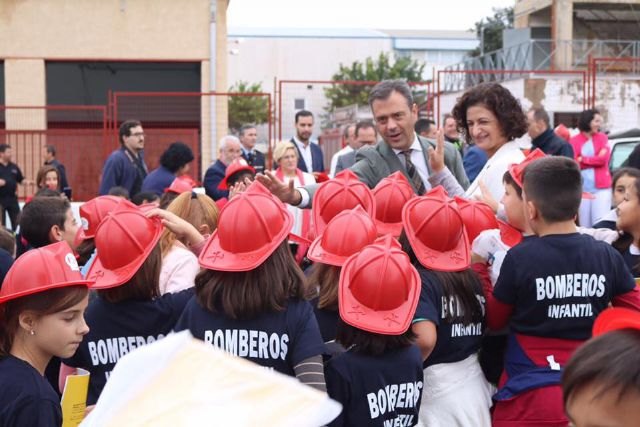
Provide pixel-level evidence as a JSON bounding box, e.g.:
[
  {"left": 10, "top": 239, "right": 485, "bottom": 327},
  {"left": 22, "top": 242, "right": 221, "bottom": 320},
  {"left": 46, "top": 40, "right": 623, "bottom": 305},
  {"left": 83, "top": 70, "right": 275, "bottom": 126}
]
[{"left": 307, "top": 205, "right": 376, "bottom": 345}]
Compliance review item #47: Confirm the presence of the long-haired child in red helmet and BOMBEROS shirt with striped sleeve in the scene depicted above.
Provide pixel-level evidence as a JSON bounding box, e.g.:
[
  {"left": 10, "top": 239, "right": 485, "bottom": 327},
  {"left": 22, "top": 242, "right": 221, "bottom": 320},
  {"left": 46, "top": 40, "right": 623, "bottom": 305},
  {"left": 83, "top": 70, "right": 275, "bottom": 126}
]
[{"left": 175, "top": 182, "right": 325, "bottom": 389}]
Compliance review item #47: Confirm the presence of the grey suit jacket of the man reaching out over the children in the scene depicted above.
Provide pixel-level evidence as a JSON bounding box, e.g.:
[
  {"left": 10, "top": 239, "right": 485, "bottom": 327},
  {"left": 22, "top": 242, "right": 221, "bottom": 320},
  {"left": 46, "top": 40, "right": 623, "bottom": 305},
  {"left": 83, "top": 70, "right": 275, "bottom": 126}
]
[{"left": 304, "top": 136, "right": 469, "bottom": 199}]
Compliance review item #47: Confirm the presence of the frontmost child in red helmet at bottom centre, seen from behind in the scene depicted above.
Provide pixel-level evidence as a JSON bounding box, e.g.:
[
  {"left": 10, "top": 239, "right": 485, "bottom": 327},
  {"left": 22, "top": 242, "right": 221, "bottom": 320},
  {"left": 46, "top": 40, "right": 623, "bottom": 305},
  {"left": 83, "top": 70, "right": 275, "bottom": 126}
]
[{"left": 326, "top": 236, "right": 423, "bottom": 426}]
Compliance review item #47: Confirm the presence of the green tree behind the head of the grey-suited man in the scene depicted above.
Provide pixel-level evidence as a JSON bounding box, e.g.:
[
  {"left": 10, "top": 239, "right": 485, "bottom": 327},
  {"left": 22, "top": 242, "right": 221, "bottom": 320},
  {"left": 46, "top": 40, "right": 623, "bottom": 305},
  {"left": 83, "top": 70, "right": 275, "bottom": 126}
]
[{"left": 324, "top": 53, "right": 425, "bottom": 111}]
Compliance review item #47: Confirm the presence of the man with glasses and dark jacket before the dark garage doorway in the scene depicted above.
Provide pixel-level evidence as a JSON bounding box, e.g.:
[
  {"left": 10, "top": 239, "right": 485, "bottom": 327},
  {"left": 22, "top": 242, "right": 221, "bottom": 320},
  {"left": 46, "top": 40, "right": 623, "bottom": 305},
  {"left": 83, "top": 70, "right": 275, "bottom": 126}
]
[{"left": 100, "top": 120, "right": 149, "bottom": 197}]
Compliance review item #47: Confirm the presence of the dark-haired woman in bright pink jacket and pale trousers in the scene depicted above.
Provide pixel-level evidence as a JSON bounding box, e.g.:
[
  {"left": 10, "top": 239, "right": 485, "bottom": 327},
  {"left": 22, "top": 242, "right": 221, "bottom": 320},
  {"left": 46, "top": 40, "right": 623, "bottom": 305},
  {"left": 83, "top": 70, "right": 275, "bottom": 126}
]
[{"left": 569, "top": 110, "right": 611, "bottom": 227}]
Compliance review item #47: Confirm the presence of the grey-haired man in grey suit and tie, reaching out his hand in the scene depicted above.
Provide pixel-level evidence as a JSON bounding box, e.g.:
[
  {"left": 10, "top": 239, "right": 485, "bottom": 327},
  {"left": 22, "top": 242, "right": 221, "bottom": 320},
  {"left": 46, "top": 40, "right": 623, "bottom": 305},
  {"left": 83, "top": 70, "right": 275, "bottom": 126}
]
[{"left": 257, "top": 80, "right": 469, "bottom": 207}]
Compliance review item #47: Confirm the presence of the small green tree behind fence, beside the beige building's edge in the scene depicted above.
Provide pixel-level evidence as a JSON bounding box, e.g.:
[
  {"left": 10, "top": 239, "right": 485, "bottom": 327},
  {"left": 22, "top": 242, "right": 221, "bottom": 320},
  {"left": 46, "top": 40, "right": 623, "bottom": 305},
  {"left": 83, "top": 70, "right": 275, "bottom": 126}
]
[{"left": 229, "top": 81, "right": 269, "bottom": 131}]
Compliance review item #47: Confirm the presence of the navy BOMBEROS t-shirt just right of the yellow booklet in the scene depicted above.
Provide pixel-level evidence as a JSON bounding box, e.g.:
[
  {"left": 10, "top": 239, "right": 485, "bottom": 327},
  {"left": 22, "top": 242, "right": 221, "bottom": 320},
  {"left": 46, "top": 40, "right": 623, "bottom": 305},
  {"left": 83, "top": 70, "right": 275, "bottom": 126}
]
[{"left": 63, "top": 288, "right": 193, "bottom": 405}]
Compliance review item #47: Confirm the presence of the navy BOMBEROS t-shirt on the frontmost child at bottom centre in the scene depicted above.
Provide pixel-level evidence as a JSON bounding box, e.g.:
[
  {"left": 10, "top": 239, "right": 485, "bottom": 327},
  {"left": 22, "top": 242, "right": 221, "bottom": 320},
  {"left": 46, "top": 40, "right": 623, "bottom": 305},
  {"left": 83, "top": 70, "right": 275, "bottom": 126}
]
[{"left": 325, "top": 345, "right": 423, "bottom": 427}]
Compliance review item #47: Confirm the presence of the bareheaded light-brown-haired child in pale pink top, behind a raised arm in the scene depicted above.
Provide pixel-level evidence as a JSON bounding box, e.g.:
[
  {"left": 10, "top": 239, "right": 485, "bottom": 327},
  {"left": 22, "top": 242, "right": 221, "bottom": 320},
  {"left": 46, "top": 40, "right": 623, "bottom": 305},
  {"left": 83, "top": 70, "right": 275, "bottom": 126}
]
[{"left": 159, "top": 192, "right": 218, "bottom": 295}]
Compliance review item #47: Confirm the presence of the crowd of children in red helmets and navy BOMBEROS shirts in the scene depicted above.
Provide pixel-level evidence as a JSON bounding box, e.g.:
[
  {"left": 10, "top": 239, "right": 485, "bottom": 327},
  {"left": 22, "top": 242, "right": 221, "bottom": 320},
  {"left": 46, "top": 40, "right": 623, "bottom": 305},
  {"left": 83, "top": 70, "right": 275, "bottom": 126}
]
[{"left": 0, "top": 109, "right": 640, "bottom": 427}]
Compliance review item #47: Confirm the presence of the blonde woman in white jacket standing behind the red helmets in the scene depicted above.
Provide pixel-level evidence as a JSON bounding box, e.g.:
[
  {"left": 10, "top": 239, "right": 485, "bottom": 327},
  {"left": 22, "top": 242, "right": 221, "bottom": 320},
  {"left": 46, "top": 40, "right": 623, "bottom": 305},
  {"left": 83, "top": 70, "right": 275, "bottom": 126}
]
[{"left": 273, "top": 141, "right": 316, "bottom": 262}]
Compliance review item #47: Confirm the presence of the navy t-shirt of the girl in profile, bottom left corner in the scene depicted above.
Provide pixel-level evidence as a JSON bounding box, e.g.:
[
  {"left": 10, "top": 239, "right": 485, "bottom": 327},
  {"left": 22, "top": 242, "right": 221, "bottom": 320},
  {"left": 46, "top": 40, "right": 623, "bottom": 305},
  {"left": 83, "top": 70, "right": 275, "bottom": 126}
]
[{"left": 0, "top": 356, "right": 62, "bottom": 427}]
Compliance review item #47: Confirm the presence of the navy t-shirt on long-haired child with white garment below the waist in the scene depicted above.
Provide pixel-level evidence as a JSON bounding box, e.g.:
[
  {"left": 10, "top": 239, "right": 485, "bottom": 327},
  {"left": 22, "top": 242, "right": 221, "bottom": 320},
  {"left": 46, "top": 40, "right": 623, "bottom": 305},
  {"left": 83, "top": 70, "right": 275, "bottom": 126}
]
[{"left": 414, "top": 268, "right": 485, "bottom": 368}]
